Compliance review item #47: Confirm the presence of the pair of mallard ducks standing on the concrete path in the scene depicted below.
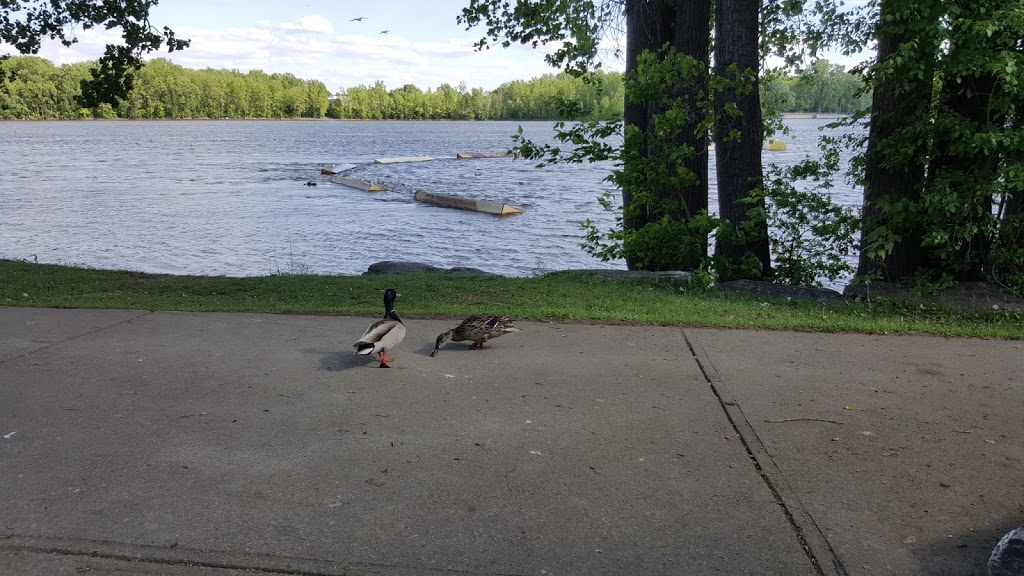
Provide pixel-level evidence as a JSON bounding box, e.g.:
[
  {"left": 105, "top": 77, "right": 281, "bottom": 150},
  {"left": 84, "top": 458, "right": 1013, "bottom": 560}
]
[{"left": 352, "top": 288, "right": 519, "bottom": 368}]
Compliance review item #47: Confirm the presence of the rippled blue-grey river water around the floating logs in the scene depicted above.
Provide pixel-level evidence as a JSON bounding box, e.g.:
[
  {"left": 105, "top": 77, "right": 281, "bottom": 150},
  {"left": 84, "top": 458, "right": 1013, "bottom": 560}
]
[{"left": 0, "top": 120, "right": 860, "bottom": 276}]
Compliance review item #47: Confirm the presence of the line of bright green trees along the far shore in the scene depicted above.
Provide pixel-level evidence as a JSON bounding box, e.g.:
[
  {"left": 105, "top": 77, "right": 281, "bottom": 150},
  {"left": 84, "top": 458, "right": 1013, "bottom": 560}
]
[{"left": 0, "top": 56, "right": 869, "bottom": 120}]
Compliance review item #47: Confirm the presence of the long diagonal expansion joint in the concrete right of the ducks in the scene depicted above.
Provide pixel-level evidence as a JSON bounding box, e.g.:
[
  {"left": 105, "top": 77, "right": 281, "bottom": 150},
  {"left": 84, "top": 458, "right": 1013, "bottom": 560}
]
[{"left": 681, "top": 330, "right": 848, "bottom": 576}]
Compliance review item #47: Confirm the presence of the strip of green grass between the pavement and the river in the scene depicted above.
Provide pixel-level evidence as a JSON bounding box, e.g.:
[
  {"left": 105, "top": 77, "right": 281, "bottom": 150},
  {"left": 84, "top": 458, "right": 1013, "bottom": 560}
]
[{"left": 0, "top": 260, "right": 1024, "bottom": 339}]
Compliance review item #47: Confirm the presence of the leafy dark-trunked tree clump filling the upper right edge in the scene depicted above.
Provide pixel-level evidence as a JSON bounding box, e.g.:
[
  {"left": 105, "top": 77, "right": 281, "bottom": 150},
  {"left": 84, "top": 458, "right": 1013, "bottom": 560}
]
[{"left": 859, "top": 0, "right": 1024, "bottom": 291}]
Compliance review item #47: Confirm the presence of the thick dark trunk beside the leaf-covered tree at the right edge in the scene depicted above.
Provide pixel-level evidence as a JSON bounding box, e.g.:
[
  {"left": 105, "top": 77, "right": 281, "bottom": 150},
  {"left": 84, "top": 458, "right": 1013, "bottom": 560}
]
[{"left": 857, "top": 0, "right": 938, "bottom": 281}]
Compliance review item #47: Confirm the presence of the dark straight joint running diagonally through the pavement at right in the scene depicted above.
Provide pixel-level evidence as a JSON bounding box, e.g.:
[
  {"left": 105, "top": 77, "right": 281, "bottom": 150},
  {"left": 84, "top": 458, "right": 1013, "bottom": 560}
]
[{"left": 680, "top": 330, "right": 849, "bottom": 576}]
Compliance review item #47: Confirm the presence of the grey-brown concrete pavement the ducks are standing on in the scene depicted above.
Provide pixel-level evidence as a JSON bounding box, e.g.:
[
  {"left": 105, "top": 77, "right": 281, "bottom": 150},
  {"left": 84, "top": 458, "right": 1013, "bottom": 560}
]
[{"left": 0, "top": 307, "right": 1024, "bottom": 576}]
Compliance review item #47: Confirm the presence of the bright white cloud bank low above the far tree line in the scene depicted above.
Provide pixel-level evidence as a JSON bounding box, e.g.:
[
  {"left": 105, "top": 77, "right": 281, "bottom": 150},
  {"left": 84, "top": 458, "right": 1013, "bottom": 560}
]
[{"left": 0, "top": 16, "right": 569, "bottom": 92}]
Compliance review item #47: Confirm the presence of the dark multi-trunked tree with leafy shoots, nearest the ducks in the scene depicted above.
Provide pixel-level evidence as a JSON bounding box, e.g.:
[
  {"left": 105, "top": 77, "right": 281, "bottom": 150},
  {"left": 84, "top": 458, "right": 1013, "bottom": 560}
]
[{"left": 460, "top": 0, "right": 770, "bottom": 277}]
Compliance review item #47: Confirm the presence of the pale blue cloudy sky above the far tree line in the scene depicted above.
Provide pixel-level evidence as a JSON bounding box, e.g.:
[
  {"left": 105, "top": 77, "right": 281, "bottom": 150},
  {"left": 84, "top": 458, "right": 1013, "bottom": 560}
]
[{"left": 12, "top": 0, "right": 581, "bottom": 92}]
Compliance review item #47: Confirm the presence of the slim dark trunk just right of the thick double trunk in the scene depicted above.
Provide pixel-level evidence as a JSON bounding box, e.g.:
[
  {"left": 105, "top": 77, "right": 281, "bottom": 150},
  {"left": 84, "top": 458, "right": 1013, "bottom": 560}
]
[{"left": 715, "top": 0, "right": 771, "bottom": 280}]
